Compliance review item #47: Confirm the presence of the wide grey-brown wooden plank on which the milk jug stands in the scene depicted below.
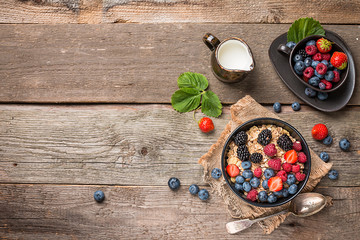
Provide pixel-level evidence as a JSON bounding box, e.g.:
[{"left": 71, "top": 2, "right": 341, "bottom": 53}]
[{"left": 0, "top": 24, "right": 360, "bottom": 104}]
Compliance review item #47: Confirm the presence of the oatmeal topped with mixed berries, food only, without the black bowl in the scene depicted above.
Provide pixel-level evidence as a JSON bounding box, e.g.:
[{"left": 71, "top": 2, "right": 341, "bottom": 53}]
[{"left": 226, "top": 125, "right": 307, "bottom": 203}]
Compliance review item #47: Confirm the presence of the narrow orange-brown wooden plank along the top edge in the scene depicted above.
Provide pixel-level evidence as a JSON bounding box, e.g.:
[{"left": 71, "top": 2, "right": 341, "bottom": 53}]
[{"left": 0, "top": 0, "right": 360, "bottom": 24}]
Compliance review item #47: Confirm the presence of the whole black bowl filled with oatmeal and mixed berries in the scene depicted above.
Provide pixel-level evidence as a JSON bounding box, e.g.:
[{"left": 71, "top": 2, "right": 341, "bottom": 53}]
[{"left": 222, "top": 118, "right": 311, "bottom": 207}]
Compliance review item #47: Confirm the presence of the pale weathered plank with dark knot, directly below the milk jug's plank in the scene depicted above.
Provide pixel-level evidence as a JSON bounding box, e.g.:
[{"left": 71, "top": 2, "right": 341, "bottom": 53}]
[{"left": 0, "top": 105, "right": 360, "bottom": 186}]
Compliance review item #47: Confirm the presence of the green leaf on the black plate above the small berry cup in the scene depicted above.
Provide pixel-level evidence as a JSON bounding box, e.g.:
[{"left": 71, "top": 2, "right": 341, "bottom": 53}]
[{"left": 287, "top": 18, "right": 325, "bottom": 43}]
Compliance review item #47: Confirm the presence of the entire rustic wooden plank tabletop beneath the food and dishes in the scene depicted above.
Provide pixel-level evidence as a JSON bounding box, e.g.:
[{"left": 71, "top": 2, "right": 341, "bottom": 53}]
[{"left": 0, "top": 0, "right": 360, "bottom": 239}]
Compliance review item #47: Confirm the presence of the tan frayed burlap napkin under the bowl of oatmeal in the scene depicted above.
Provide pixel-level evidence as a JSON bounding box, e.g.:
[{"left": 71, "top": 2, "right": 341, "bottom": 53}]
[{"left": 199, "top": 96, "right": 332, "bottom": 234}]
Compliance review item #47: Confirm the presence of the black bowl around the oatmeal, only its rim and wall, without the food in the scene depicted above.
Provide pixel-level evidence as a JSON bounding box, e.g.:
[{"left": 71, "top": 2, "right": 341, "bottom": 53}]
[{"left": 221, "top": 118, "right": 311, "bottom": 207}]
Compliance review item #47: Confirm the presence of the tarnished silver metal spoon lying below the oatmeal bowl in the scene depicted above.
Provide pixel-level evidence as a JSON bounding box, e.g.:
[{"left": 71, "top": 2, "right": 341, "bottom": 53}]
[{"left": 226, "top": 192, "right": 326, "bottom": 234}]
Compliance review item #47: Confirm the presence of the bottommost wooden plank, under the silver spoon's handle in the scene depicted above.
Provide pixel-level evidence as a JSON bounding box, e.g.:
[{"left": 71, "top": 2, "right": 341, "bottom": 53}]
[{"left": 0, "top": 184, "right": 360, "bottom": 239}]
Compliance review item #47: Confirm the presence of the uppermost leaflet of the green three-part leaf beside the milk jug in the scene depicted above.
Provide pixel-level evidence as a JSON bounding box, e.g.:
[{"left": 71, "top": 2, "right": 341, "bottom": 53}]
[{"left": 178, "top": 72, "right": 209, "bottom": 91}]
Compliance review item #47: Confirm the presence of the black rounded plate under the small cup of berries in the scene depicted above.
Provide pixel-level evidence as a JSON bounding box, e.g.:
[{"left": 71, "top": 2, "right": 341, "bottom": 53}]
[{"left": 269, "top": 30, "right": 355, "bottom": 112}]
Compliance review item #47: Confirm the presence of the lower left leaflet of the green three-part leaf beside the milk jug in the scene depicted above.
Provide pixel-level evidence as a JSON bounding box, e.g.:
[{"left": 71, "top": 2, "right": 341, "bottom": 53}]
[{"left": 171, "top": 88, "right": 201, "bottom": 112}]
